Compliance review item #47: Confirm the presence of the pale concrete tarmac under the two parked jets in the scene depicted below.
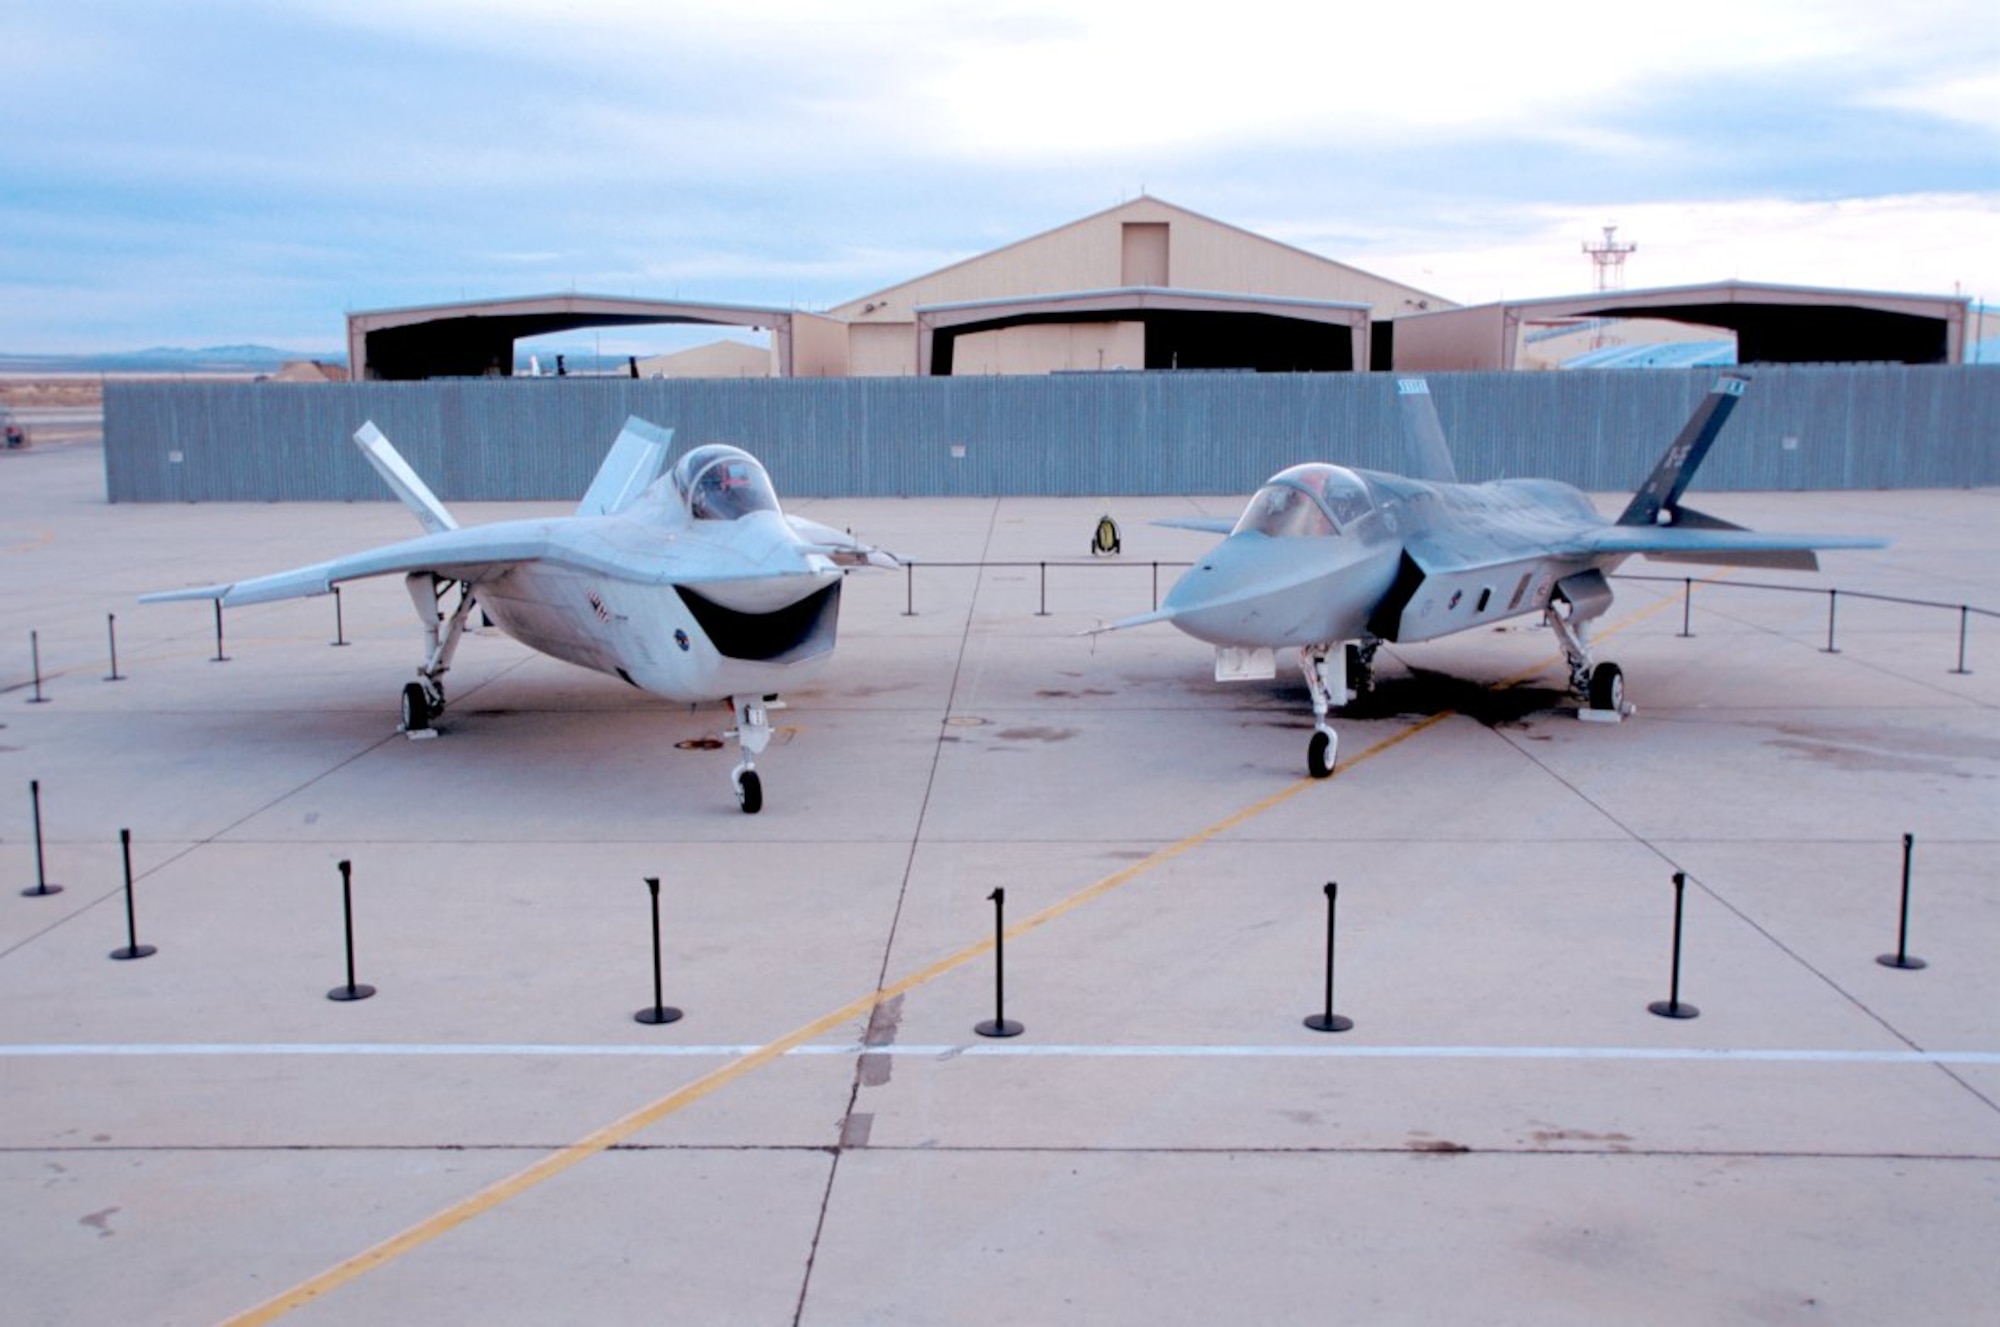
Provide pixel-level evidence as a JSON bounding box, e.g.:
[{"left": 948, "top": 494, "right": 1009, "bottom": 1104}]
[{"left": 0, "top": 440, "right": 2000, "bottom": 1325}]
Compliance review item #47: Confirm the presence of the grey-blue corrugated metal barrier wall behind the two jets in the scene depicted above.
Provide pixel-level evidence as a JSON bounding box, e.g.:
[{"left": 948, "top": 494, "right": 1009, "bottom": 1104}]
[{"left": 104, "top": 366, "right": 2000, "bottom": 502}]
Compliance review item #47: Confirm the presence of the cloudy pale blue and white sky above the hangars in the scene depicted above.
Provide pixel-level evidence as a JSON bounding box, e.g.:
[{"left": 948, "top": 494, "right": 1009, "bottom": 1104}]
[{"left": 0, "top": 0, "right": 2000, "bottom": 352}]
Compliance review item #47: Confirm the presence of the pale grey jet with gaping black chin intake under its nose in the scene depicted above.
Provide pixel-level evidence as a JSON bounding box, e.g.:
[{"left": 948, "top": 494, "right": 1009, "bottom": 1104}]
[{"left": 142, "top": 418, "right": 898, "bottom": 811}]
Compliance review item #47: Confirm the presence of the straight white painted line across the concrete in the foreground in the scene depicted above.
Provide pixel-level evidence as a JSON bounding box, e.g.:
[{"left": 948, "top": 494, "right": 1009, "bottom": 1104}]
[{"left": 0, "top": 1041, "right": 2000, "bottom": 1065}]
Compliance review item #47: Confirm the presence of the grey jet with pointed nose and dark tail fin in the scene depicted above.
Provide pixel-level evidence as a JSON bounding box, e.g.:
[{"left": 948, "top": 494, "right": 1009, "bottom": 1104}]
[{"left": 1104, "top": 376, "right": 1886, "bottom": 779}]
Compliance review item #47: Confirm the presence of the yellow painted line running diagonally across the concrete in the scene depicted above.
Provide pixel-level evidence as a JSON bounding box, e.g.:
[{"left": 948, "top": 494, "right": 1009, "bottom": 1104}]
[{"left": 224, "top": 598, "right": 1674, "bottom": 1327}]
